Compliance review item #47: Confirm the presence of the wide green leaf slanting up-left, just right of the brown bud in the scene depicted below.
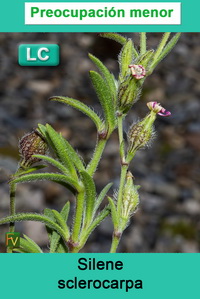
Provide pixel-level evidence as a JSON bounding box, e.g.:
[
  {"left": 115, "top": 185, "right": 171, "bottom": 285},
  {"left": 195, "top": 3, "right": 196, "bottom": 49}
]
[{"left": 46, "top": 124, "right": 77, "bottom": 178}]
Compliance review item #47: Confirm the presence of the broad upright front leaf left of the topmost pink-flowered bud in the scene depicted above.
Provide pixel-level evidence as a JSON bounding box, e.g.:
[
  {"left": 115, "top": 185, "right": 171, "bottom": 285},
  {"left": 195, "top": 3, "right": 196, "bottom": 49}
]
[{"left": 90, "top": 71, "right": 115, "bottom": 133}]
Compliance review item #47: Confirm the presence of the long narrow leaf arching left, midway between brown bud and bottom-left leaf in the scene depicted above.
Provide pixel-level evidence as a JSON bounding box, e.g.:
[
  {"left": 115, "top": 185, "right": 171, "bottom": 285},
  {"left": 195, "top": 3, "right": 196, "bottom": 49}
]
[{"left": 12, "top": 172, "right": 80, "bottom": 192}]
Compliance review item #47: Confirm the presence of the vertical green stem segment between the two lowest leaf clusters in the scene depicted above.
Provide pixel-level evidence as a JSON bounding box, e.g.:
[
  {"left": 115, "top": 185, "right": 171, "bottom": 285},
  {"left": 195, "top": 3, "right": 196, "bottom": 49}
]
[{"left": 72, "top": 191, "right": 85, "bottom": 243}]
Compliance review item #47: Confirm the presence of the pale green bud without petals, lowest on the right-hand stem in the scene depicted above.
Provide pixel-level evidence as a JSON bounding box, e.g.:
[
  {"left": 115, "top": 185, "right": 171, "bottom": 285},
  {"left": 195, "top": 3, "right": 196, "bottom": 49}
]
[{"left": 122, "top": 171, "right": 139, "bottom": 220}]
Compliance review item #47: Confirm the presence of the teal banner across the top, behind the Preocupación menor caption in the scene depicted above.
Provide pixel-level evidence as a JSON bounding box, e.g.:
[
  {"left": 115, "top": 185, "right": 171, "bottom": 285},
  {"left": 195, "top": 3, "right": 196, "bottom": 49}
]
[{"left": 0, "top": 0, "right": 200, "bottom": 32}]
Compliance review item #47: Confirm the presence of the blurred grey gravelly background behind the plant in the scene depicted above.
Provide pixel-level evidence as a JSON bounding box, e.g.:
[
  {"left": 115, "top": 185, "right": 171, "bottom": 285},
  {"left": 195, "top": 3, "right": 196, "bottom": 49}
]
[{"left": 0, "top": 33, "right": 200, "bottom": 252}]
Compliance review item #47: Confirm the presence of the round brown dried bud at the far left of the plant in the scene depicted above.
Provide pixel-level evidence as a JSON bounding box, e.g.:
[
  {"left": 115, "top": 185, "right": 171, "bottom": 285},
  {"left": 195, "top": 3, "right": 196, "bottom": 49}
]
[{"left": 19, "top": 130, "right": 47, "bottom": 167}]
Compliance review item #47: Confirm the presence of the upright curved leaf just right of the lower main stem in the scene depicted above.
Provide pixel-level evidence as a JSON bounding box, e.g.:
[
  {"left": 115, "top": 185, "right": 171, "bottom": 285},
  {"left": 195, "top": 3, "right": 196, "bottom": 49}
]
[{"left": 80, "top": 171, "right": 96, "bottom": 226}]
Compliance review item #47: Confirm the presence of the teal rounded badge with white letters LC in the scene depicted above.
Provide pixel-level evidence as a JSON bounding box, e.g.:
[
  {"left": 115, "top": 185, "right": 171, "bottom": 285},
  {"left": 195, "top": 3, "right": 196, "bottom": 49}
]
[{"left": 18, "top": 44, "right": 60, "bottom": 66}]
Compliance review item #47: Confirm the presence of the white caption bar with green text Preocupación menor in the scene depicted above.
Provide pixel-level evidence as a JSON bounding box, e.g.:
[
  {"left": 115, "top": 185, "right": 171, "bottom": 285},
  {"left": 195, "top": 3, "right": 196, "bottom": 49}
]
[{"left": 25, "top": 2, "right": 181, "bottom": 25}]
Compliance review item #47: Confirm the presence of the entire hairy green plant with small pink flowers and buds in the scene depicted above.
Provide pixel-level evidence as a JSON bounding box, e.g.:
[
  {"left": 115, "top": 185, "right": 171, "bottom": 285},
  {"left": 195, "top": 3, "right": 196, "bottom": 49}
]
[{"left": 0, "top": 33, "right": 180, "bottom": 253}]
